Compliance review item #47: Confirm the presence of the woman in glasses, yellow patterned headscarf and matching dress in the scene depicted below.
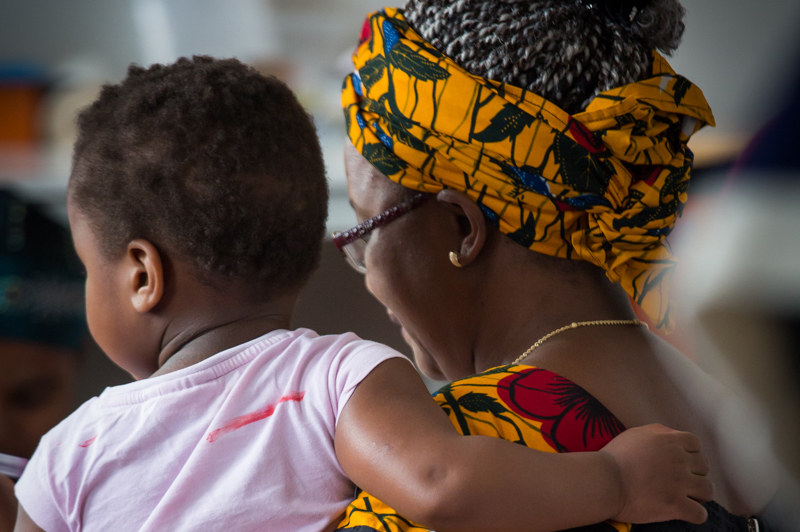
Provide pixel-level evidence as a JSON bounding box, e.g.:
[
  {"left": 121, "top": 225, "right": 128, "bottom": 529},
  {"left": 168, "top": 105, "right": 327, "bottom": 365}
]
[{"left": 335, "top": 0, "right": 756, "bottom": 531}]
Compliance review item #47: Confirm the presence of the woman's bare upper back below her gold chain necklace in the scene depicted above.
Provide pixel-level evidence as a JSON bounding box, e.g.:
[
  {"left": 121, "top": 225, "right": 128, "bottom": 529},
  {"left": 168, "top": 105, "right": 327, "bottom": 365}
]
[{"left": 529, "top": 328, "right": 769, "bottom": 515}]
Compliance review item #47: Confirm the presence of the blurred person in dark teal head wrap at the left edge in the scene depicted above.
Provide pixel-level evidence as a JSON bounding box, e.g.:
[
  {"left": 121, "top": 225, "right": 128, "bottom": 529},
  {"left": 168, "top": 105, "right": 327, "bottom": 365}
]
[{"left": 0, "top": 189, "right": 87, "bottom": 530}]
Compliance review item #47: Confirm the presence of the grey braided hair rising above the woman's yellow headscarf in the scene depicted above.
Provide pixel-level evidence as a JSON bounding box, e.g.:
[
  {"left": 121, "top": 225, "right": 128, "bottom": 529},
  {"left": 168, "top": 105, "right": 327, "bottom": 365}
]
[{"left": 405, "top": 0, "right": 686, "bottom": 114}]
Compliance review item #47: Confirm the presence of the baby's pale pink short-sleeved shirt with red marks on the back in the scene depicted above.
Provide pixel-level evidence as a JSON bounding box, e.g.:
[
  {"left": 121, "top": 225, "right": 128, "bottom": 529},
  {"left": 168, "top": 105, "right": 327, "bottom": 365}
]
[{"left": 16, "top": 329, "right": 402, "bottom": 532}]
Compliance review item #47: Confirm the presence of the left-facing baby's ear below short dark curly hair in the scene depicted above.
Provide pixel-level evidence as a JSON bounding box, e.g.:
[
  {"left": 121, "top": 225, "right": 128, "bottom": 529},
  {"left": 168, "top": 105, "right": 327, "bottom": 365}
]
[{"left": 126, "top": 239, "right": 164, "bottom": 313}]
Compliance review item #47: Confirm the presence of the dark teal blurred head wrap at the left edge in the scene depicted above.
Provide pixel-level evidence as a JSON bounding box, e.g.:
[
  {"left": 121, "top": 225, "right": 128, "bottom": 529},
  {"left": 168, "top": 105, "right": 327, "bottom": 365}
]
[{"left": 0, "top": 190, "right": 87, "bottom": 350}]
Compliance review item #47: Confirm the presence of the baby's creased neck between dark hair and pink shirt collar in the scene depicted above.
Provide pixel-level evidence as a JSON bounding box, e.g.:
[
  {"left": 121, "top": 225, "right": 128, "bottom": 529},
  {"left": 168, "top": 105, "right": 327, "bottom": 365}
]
[{"left": 151, "top": 298, "right": 294, "bottom": 377}]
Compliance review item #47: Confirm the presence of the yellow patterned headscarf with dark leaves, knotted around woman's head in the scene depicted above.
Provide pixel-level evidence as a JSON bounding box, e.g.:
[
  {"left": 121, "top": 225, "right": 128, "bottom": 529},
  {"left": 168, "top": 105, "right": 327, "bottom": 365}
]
[{"left": 342, "top": 8, "right": 714, "bottom": 330}]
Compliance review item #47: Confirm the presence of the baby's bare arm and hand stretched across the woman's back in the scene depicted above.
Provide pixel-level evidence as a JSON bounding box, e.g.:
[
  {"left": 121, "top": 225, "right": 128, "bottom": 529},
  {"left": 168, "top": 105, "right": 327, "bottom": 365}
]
[{"left": 336, "top": 359, "right": 713, "bottom": 532}]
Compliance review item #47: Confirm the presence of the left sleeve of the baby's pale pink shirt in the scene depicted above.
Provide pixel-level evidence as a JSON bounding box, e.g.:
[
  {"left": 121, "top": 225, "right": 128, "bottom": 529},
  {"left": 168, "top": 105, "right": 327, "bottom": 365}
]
[{"left": 14, "top": 436, "right": 70, "bottom": 532}]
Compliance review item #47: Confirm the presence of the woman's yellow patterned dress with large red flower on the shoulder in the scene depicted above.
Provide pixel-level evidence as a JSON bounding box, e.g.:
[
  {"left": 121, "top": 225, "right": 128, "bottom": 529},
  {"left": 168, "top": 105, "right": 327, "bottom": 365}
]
[{"left": 337, "top": 365, "right": 631, "bottom": 532}]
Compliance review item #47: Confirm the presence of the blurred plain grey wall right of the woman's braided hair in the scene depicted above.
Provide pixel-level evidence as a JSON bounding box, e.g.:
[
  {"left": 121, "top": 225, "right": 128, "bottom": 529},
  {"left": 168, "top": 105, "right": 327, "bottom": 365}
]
[{"left": 671, "top": 0, "right": 800, "bottom": 134}]
